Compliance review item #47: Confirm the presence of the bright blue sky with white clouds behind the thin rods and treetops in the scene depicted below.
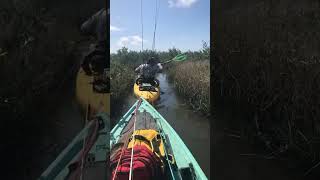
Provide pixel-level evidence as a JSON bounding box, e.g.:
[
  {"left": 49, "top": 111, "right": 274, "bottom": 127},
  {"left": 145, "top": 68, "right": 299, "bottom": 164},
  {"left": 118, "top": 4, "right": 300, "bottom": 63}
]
[{"left": 110, "top": 0, "right": 210, "bottom": 52}]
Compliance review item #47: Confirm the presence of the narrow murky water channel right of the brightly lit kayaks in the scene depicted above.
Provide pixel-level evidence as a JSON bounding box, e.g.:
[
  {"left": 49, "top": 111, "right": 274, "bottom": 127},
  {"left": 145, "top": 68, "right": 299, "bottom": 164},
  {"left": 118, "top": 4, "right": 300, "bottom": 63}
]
[{"left": 156, "top": 74, "right": 210, "bottom": 179}]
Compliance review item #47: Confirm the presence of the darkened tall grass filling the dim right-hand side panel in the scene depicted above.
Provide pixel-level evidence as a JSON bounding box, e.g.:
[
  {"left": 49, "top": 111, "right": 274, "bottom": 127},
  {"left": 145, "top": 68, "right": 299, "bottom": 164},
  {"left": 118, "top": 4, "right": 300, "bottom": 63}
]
[{"left": 214, "top": 0, "right": 320, "bottom": 168}]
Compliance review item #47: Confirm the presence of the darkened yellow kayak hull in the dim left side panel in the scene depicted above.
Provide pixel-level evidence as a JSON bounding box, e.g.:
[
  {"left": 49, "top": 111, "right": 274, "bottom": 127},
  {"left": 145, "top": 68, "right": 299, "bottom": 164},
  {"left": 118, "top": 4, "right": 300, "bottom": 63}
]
[{"left": 76, "top": 68, "right": 110, "bottom": 115}]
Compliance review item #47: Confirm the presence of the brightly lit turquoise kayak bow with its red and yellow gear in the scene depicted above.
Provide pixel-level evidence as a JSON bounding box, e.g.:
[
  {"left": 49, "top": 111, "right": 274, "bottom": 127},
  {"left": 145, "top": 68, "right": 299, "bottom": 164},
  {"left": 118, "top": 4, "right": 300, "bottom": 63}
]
[{"left": 110, "top": 98, "right": 207, "bottom": 180}]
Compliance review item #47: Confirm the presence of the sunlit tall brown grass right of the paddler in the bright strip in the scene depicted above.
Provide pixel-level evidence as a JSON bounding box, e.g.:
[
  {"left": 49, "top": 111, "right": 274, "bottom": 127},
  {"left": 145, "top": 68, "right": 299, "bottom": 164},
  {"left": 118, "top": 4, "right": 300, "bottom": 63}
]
[{"left": 167, "top": 41, "right": 210, "bottom": 115}]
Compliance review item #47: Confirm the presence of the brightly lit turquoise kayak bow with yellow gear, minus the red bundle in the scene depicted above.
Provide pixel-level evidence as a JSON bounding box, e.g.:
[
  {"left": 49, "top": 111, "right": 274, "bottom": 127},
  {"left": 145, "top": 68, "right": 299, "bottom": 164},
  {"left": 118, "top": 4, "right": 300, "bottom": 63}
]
[{"left": 110, "top": 98, "right": 207, "bottom": 180}]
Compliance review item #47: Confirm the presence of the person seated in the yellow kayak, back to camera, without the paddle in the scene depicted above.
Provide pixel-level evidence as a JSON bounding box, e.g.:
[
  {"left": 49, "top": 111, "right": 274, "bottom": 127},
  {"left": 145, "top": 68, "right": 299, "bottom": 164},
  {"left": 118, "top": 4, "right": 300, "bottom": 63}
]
[{"left": 135, "top": 57, "right": 163, "bottom": 85}]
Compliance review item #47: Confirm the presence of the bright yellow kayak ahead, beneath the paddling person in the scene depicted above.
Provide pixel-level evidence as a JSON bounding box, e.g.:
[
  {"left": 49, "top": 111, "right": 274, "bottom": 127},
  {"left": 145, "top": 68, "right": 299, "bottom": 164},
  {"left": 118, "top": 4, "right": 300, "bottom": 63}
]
[{"left": 133, "top": 83, "right": 160, "bottom": 103}]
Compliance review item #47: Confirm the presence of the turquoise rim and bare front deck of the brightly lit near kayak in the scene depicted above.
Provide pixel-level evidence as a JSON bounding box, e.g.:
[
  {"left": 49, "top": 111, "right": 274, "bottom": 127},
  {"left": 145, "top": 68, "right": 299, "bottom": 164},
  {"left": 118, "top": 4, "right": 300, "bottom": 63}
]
[{"left": 110, "top": 98, "right": 207, "bottom": 180}]
